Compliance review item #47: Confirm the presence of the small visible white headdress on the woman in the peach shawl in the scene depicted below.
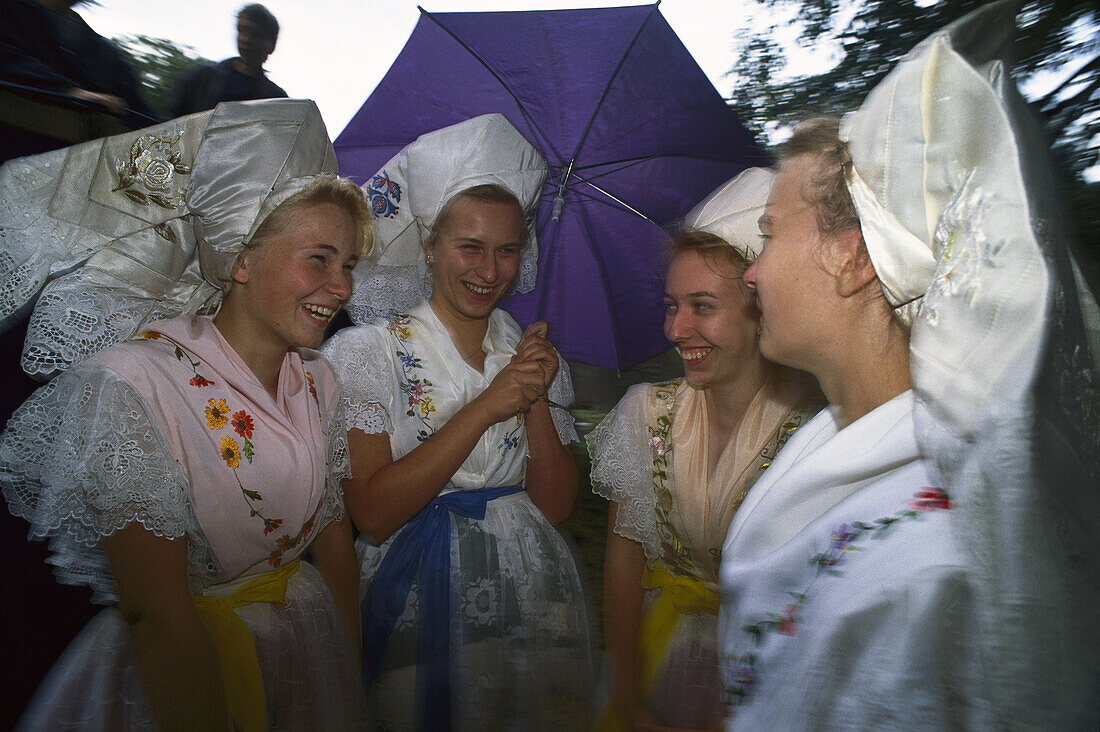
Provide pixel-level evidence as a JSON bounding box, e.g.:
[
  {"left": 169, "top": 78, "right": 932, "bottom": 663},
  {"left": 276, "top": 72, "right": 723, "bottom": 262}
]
[{"left": 684, "top": 167, "right": 776, "bottom": 262}]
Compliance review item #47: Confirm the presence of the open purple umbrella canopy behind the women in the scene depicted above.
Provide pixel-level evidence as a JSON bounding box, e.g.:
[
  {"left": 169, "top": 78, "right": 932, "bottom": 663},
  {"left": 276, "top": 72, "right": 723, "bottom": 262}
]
[{"left": 336, "top": 4, "right": 769, "bottom": 369}]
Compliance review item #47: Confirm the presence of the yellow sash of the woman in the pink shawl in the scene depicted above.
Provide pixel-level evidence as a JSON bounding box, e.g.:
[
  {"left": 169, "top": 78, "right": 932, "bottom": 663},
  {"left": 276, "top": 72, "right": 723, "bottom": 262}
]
[{"left": 194, "top": 559, "right": 299, "bottom": 732}]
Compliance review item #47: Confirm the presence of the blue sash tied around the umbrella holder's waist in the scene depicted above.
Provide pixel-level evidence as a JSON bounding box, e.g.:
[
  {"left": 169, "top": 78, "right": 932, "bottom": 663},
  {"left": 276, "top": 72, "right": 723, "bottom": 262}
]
[{"left": 363, "top": 483, "right": 524, "bottom": 730}]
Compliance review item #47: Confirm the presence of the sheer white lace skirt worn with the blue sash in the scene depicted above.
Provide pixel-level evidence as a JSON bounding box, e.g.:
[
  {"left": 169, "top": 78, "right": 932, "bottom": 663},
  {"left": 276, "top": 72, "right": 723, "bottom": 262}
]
[{"left": 358, "top": 493, "right": 593, "bottom": 732}]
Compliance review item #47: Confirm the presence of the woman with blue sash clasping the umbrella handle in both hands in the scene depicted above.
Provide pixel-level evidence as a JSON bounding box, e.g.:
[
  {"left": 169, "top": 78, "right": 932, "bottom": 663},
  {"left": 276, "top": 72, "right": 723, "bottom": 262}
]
[{"left": 325, "top": 114, "right": 591, "bottom": 730}]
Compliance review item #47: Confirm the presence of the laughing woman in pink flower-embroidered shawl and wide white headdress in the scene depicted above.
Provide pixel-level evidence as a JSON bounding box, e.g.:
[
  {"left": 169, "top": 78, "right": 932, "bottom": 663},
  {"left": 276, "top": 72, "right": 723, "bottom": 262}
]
[{"left": 0, "top": 101, "right": 373, "bottom": 730}]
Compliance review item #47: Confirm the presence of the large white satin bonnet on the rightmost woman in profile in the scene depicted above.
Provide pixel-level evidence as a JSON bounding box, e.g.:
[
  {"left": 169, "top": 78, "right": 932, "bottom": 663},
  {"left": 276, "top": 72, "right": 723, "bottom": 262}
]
[{"left": 842, "top": 1, "right": 1049, "bottom": 435}]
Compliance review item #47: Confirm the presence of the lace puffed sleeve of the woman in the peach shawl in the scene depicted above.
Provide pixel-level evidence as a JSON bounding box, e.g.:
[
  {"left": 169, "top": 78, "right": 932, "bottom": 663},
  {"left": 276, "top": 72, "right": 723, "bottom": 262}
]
[{"left": 585, "top": 384, "right": 658, "bottom": 559}]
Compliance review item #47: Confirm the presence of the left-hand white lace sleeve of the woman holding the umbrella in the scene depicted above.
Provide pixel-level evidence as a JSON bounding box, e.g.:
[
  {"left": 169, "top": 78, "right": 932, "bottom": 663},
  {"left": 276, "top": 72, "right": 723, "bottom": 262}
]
[{"left": 321, "top": 325, "right": 397, "bottom": 435}]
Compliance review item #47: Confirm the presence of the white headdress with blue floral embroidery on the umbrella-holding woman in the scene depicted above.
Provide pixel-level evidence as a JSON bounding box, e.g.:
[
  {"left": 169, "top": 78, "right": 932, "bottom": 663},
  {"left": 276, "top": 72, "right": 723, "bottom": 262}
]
[{"left": 347, "top": 114, "right": 547, "bottom": 324}]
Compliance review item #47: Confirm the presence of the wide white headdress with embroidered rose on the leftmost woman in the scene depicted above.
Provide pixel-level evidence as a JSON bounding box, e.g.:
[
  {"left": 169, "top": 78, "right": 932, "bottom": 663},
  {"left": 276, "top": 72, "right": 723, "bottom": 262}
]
[{"left": 0, "top": 99, "right": 336, "bottom": 379}]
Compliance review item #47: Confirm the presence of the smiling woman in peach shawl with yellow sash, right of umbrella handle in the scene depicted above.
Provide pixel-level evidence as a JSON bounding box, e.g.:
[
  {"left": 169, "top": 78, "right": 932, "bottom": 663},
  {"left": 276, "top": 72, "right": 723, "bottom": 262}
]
[{"left": 587, "top": 168, "right": 821, "bottom": 730}]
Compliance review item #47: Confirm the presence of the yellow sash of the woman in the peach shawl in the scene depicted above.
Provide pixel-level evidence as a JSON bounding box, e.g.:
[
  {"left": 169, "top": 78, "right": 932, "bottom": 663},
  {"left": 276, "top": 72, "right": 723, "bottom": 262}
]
[{"left": 593, "top": 565, "right": 718, "bottom": 732}]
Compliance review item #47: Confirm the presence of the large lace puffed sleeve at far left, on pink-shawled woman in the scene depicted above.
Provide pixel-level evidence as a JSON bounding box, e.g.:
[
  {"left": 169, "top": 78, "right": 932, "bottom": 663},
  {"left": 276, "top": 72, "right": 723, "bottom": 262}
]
[{"left": 0, "top": 364, "right": 195, "bottom": 602}]
